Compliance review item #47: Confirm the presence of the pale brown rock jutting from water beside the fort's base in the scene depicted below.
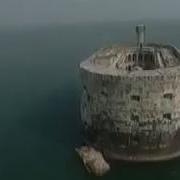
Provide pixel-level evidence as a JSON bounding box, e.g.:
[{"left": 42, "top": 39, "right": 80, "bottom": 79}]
[{"left": 76, "top": 146, "right": 110, "bottom": 176}]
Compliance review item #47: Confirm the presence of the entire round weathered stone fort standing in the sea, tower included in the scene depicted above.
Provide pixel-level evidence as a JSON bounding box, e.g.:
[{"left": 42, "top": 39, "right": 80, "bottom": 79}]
[{"left": 77, "top": 25, "right": 180, "bottom": 169}]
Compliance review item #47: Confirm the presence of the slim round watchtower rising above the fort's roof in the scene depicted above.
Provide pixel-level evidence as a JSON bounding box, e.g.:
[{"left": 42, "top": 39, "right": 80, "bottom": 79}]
[{"left": 136, "top": 24, "right": 146, "bottom": 49}]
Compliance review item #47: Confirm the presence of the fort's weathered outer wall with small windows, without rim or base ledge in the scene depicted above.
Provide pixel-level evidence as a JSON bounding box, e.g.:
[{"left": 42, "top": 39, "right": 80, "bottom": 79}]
[{"left": 80, "top": 69, "right": 180, "bottom": 150}]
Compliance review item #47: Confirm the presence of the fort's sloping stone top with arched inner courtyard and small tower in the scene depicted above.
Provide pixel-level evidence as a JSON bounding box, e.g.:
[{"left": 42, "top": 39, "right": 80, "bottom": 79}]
[{"left": 82, "top": 25, "right": 180, "bottom": 74}]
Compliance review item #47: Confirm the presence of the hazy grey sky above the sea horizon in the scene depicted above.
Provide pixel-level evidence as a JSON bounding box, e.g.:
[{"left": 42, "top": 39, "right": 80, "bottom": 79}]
[{"left": 0, "top": 0, "right": 180, "bottom": 26}]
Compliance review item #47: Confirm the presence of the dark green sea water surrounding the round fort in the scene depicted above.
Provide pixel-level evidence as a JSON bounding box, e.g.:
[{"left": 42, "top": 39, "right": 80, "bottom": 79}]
[{"left": 0, "top": 21, "right": 180, "bottom": 180}]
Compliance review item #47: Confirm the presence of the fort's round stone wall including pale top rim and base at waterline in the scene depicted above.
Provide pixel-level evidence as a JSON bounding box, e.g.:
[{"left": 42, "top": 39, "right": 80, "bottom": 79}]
[{"left": 80, "top": 45, "right": 180, "bottom": 161}]
